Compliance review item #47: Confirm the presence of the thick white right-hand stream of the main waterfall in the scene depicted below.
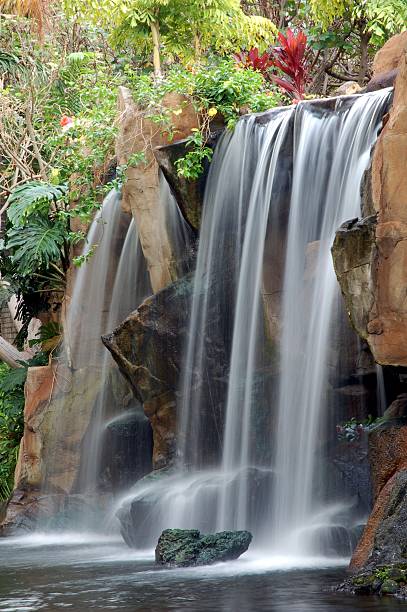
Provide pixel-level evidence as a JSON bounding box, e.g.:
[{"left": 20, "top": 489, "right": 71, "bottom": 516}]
[{"left": 272, "top": 92, "right": 389, "bottom": 555}]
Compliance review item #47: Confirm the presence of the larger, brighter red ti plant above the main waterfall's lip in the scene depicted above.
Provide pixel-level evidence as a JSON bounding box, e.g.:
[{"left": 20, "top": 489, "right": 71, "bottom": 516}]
[{"left": 268, "top": 28, "right": 309, "bottom": 100}]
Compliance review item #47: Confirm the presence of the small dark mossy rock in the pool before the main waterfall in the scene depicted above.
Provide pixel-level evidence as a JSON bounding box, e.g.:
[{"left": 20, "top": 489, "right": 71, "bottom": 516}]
[{"left": 155, "top": 529, "right": 252, "bottom": 567}]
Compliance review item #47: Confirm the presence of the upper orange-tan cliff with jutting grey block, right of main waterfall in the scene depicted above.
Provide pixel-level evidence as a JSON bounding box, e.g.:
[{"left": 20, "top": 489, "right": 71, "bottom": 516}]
[{"left": 333, "top": 40, "right": 407, "bottom": 366}]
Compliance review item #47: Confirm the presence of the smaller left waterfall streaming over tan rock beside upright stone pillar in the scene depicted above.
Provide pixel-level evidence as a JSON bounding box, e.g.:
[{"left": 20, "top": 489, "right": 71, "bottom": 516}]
[{"left": 44, "top": 190, "right": 151, "bottom": 504}]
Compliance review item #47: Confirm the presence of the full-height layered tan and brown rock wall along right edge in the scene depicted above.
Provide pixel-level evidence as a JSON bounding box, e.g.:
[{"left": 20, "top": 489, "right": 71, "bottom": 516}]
[{"left": 332, "top": 32, "right": 407, "bottom": 580}]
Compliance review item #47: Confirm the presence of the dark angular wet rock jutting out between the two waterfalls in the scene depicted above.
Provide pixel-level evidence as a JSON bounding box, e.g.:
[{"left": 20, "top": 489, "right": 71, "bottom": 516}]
[{"left": 103, "top": 277, "right": 192, "bottom": 469}]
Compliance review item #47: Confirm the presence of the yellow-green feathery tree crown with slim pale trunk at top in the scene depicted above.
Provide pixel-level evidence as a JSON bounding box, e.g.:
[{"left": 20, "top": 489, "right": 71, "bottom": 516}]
[{"left": 65, "top": 0, "right": 276, "bottom": 76}]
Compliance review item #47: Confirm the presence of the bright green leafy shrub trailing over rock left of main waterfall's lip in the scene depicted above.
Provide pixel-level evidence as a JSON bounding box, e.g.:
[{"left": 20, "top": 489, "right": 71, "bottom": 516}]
[{"left": 127, "top": 58, "right": 282, "bottom": 179}]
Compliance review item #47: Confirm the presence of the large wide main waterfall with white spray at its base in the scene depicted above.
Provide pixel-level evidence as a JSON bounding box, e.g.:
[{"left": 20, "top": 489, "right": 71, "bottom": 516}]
[{"left": 115, "top": 90, "right": 390, "bottom": 556}]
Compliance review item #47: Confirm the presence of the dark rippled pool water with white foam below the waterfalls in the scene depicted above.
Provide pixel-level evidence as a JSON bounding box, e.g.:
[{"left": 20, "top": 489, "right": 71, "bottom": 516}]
[{"left": 0, "top": 535, "right": 407, "bottom": 612}]
